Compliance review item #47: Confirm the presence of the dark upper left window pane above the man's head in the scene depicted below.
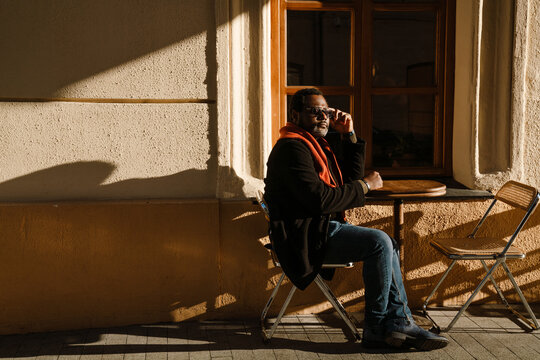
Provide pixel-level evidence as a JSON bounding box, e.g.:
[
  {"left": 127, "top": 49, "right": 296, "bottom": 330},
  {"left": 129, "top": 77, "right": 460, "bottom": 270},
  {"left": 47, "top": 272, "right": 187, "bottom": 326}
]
[{"left": 287, "top": 11, "right": 351, "bottom": 85}]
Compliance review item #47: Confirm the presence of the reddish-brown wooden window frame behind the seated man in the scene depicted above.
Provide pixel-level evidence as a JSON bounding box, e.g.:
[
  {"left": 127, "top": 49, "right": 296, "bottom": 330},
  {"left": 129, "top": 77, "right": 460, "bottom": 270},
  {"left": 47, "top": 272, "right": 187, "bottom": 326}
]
[{"left": 270, "top": 0, "right": 456, "bottom": 177}]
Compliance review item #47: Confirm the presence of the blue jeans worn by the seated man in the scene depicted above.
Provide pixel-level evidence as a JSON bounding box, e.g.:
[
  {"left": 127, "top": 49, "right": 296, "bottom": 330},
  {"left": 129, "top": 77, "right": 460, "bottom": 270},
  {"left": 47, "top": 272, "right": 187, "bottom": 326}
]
[{"left": 324, "top": 221, "right": 412, "bottom": 327}]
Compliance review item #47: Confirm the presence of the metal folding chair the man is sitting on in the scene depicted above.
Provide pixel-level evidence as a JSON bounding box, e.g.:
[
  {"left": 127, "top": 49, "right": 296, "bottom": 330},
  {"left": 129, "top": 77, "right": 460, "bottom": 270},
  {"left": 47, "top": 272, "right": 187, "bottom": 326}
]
[{"left": 257, "top": 191, "right": 360, "bottom": 342}]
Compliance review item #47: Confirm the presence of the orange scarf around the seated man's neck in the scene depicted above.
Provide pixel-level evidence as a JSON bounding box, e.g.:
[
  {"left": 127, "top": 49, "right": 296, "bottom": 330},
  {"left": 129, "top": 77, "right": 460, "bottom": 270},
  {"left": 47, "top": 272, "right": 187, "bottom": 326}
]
[{"left": 279, "top": 122, "right": 343, "bottom": 187}]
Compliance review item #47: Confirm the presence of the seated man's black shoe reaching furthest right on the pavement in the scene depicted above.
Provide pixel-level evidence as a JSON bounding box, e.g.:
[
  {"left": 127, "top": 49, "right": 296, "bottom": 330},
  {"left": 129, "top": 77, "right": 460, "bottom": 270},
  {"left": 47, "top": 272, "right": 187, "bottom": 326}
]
[{"left": 384, "top": 319, "right": 448, "bottom": 350}]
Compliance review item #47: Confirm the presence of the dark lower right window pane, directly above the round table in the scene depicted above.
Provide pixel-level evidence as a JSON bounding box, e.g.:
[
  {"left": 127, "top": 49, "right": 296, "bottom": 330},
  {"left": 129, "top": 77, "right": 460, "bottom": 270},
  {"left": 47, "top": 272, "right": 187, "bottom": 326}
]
[{"left": 372, "top": 95, "right": 435, "bottom": 168}]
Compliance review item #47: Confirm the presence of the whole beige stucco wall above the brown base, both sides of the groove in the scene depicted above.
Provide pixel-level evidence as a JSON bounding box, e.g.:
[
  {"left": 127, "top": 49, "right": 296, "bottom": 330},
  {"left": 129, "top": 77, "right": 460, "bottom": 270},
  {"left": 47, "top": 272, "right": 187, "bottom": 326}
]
[{"left": 0, "top": 0, "right": 218, "bottom": 200}]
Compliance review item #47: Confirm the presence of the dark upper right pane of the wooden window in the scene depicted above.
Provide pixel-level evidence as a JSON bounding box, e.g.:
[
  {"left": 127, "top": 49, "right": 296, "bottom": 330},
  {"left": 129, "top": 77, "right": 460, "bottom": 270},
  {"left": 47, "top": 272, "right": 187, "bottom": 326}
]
[{"left": 372, "top": 11, "right": 436, "bottom": 87}]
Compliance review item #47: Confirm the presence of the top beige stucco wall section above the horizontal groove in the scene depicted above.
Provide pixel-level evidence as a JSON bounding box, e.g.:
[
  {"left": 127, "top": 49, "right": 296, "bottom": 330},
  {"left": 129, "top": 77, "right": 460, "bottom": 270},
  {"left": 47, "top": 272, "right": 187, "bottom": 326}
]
[{"left": 0, "top": 0, "right": 215, "bottom": 98}]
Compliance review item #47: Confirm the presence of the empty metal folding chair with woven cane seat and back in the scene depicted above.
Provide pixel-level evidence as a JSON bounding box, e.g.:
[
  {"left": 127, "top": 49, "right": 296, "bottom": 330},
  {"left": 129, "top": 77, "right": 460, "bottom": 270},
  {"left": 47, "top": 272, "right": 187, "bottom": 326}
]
[{"left": 423, "top": 181, "right": 540, "bottom": 331}]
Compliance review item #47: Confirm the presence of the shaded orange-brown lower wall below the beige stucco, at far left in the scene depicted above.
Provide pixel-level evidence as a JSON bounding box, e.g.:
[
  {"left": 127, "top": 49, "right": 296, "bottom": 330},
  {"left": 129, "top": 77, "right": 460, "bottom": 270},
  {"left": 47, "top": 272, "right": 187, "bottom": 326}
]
[{"left": 0, "top": 200, "right": 220, "bottom": 333}]
